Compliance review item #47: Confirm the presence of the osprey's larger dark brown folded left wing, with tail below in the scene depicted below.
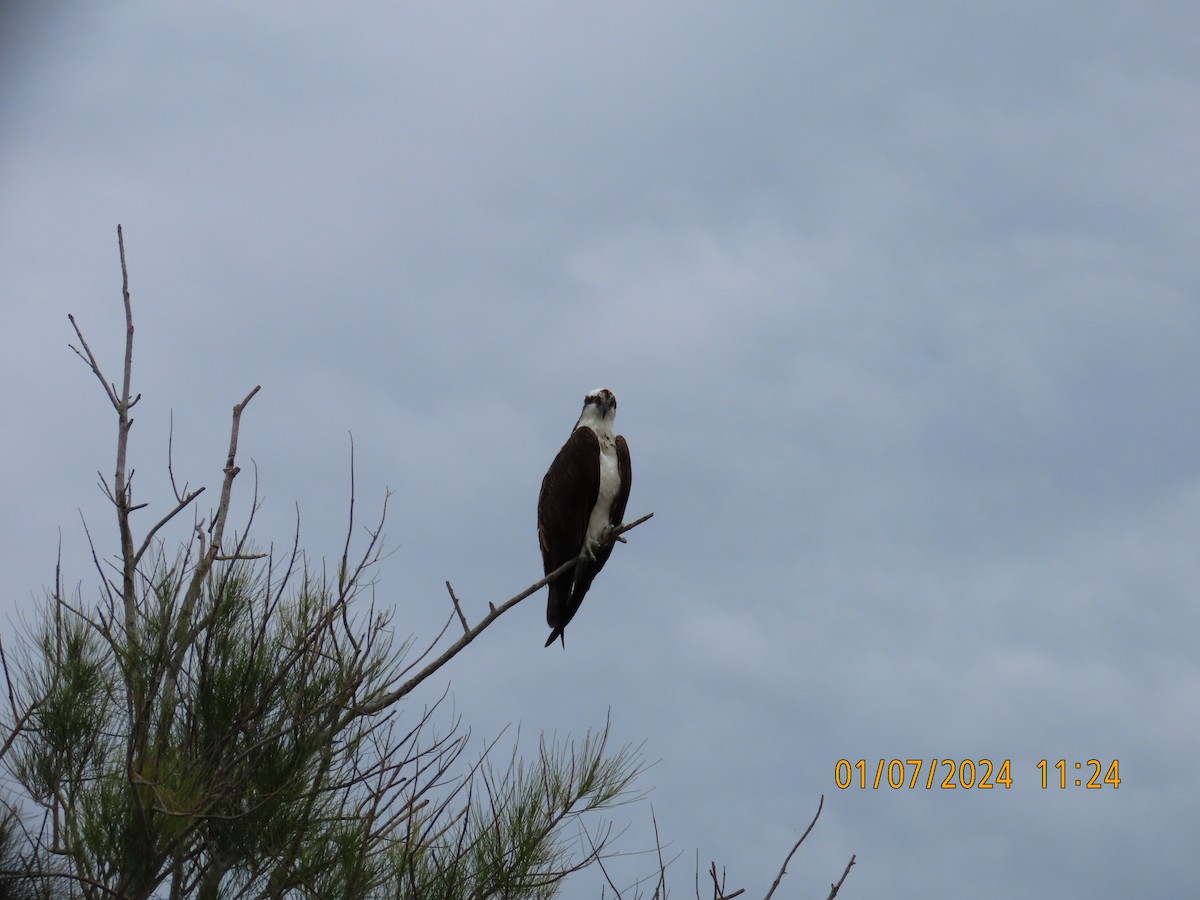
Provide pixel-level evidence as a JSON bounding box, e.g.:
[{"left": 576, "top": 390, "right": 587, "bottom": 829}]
[{"left": 538, "top": 427, "right": 600, "bottom": 647}]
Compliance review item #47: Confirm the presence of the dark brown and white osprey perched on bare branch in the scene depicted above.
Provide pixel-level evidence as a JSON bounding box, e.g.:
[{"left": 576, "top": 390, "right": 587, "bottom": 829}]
[{"left": 538, "top": 388, "right": 634, "bottom": 647}]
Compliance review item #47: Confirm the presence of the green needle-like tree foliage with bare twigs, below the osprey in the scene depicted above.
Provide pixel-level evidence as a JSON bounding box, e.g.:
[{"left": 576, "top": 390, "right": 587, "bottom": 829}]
[{"left": 0, "top": 228, "right": 641, "bottom": 900}]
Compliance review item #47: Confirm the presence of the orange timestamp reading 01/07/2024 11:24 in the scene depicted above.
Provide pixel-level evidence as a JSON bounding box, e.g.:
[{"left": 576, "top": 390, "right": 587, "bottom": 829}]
[{"left": 833, "top": 758, "right": 1121, "bottom": 791}]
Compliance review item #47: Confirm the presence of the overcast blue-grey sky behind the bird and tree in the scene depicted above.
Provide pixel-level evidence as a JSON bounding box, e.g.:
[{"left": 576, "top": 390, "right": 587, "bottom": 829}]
[{"left": 0, "top": 0, "right": 1200, "bottom": 900}]
